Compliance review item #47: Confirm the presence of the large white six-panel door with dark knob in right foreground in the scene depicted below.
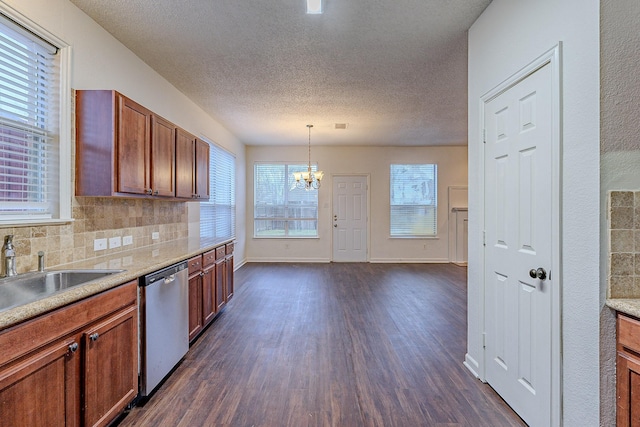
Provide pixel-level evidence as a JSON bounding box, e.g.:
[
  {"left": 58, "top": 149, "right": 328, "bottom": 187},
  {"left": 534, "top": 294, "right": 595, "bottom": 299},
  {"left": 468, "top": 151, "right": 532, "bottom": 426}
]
[{"left": 484, "top": 63, "right": 559, "bottom": 426}]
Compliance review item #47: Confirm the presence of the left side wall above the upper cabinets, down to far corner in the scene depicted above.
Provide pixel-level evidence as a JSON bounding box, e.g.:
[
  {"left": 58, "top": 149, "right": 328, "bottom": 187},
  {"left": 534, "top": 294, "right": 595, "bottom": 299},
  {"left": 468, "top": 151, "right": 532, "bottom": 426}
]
[{"left": 1, "top": 0, "right": 246, "bottom": 264}]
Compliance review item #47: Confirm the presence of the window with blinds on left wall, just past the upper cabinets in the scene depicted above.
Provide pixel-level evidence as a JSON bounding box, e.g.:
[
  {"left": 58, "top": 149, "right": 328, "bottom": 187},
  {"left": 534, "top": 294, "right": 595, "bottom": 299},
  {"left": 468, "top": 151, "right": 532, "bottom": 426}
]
[{"left": 200, "top": 144, "right": 236, "bottom": 239}]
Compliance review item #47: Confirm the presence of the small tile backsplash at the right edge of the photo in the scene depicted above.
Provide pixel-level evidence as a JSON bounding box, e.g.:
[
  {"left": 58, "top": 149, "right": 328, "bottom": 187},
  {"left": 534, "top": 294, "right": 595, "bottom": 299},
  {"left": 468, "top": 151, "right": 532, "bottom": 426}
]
[{"left": 607, "top": 191, "right": 640, "bottom": 298}]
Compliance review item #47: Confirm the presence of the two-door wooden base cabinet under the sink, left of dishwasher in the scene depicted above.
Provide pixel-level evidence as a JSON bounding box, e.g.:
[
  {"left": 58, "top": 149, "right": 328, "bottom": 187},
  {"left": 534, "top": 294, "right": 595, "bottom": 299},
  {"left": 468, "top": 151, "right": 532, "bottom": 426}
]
[{"left": 0, "top": 281, "right": 138, "bottom": 426}]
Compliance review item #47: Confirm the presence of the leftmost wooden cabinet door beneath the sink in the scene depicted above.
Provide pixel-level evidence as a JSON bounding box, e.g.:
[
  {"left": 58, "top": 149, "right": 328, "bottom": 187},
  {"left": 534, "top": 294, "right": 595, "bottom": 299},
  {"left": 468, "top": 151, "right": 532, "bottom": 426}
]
[{"left": 0, "top": 339, "right": 80, "bottom": 427}]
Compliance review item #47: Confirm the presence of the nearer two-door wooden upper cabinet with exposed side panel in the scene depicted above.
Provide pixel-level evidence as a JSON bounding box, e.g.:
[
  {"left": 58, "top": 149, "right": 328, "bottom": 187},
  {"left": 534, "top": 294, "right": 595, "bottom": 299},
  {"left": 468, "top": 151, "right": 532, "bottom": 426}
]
[{"left": 76, "top": 90, "right": 176, "bottom": 199}]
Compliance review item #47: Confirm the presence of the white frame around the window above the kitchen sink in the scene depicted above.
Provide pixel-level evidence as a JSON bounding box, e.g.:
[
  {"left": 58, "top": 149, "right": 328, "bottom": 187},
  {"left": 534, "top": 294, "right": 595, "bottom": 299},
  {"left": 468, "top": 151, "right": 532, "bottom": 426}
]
[{"left": 0, "top": 3, "right": 73, "bottom": 227}]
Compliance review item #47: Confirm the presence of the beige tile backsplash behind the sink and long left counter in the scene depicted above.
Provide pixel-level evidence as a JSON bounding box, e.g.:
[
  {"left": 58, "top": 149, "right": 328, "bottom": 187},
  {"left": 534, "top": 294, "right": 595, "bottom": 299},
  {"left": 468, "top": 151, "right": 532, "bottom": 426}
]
[{"left": 0, "top": 197, "right": 189, "bottom": 273}]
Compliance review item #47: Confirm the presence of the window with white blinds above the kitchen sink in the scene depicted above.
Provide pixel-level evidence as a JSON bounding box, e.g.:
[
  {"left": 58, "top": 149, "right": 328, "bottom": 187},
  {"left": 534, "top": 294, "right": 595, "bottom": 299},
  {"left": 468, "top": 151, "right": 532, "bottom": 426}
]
[{"left": 0, "top": 15, "right": 60, "bottom": 223}]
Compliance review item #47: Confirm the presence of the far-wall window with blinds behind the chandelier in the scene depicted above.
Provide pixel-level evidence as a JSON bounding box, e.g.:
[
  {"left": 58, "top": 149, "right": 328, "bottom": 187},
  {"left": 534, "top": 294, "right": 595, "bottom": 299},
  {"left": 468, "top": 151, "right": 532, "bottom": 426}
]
[{"left": 253, "top": 163, "right": 318, "bottom": 237}]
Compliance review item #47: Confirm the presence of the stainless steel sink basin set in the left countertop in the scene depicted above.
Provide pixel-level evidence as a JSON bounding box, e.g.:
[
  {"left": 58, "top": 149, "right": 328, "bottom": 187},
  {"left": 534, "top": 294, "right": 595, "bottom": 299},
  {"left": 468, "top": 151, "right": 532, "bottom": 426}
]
[{"left": 0, "top": 270, "right": 124, "bottom": 312}]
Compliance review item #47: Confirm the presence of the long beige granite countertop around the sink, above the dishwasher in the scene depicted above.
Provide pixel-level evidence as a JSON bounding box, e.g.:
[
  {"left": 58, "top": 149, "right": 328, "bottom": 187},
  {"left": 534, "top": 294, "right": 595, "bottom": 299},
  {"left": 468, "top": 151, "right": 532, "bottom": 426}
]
[{"left": 0, "top": 238, "right": 232, "bottom": 330}]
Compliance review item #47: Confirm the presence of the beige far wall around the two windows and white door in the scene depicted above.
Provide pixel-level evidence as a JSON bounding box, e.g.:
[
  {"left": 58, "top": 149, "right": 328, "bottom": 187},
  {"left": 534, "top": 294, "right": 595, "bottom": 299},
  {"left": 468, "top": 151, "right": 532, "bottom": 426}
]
[{"left": 246, "top": 145, "right": 467, "bottom": 262}]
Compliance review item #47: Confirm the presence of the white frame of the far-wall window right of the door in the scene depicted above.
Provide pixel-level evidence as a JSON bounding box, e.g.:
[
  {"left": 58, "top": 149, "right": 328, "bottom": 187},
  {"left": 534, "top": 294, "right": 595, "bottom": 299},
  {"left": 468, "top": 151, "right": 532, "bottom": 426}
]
[{"left": 389, "top": 163, "right": 438, "bottom": 239}]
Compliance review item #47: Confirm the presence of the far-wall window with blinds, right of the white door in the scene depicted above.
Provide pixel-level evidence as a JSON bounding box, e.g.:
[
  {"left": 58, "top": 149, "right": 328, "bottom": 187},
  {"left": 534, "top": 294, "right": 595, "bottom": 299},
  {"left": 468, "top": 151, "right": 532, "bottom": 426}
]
[{"left": 390, "top": 164, "right": 438, "bottom": 237}]
